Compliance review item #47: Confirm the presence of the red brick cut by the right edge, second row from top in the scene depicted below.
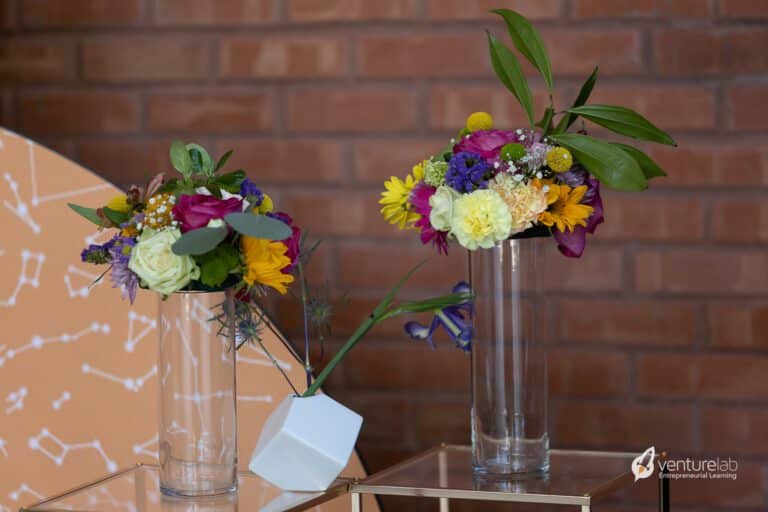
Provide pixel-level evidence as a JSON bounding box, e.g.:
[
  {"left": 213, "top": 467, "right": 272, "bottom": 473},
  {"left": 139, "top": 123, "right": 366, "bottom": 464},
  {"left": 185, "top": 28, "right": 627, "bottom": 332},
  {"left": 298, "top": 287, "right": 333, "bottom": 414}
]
[{"left": 654, "top": 29, "right": 768, "bottom": 76}]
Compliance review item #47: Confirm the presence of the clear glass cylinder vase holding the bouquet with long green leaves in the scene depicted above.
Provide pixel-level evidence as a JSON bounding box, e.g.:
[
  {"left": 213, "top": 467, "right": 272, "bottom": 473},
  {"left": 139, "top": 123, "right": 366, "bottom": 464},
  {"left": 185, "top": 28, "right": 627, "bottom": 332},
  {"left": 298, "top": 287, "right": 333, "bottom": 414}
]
[{"left": 469, "top": 238, "right": 549, "bottom": 475}]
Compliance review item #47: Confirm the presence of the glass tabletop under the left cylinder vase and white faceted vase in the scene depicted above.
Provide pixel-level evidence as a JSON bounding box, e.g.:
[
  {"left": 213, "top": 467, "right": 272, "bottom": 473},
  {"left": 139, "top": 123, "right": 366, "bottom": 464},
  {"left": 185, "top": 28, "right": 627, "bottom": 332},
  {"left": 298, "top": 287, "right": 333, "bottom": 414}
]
[{"left": 21, "top": 464, "right": 349, "bottom": 512}]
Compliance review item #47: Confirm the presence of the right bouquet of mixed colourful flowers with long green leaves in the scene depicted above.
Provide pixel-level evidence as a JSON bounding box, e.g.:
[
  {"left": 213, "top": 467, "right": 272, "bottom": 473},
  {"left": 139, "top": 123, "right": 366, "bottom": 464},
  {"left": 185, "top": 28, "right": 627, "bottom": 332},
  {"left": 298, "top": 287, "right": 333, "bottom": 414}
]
[{"left": 379, "top": 9, "right": 676, "bottom": 257}]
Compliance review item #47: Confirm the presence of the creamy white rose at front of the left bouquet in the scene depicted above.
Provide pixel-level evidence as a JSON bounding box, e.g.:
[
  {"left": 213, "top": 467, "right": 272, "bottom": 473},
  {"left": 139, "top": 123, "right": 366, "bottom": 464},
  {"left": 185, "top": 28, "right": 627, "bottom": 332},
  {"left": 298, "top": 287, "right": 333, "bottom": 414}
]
[{"left": 128, "top": 229, "right": 200, "bottom": 295}]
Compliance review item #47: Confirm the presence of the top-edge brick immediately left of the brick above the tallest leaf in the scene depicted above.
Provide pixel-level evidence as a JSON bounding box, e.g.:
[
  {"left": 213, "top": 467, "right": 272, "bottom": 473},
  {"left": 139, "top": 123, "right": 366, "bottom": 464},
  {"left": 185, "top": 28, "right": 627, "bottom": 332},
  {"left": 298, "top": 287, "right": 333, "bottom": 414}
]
[{"left": 287, "top": 0, "right": 416, "bottom": 22}]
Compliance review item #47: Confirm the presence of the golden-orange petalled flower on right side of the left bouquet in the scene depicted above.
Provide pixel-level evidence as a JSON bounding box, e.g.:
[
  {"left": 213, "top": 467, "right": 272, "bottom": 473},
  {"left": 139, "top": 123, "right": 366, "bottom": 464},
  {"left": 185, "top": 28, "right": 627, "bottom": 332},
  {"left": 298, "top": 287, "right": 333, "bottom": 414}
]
[{"left": 240, "top": 236, "right": 293, "bottom": 295}]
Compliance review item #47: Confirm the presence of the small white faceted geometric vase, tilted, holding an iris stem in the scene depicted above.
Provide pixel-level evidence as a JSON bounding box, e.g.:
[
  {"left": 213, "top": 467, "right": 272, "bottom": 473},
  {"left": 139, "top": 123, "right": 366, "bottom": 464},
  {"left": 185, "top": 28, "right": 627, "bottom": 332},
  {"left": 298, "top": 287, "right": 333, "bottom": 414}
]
[{"left": 248, "top": 395, "right": 363, "bottom": 491}]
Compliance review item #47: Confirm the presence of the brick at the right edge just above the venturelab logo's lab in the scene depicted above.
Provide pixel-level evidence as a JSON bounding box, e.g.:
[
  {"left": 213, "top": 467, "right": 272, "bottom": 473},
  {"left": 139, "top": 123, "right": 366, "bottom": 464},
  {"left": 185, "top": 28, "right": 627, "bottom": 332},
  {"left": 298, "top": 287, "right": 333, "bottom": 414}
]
[{"left": 701, "top": 407, "right": 768, "bottom": 455}]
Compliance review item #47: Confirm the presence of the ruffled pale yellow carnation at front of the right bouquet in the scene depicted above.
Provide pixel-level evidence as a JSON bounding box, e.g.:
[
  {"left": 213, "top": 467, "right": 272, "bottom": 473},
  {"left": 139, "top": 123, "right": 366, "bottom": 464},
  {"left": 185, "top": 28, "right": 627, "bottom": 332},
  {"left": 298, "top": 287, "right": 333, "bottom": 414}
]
[{"left": 451, "top": 189, "right": 512, "bottom": 251}]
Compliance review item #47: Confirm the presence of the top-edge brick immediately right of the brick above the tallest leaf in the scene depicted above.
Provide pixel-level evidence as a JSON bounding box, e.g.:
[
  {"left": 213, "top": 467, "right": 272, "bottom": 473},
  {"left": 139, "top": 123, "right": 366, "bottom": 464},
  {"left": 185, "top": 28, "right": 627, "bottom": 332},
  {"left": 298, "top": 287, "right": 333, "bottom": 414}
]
[{"left": 573, "top": 0, "right": 711, "bottom": 19}]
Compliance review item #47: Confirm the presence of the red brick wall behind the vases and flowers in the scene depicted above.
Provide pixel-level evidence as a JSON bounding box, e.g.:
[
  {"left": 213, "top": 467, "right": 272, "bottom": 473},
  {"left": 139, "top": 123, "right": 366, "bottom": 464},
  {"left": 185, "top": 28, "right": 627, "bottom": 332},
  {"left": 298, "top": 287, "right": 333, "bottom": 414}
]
[{"left": 0, "top": 0, "right": 768, "bottom": 511}]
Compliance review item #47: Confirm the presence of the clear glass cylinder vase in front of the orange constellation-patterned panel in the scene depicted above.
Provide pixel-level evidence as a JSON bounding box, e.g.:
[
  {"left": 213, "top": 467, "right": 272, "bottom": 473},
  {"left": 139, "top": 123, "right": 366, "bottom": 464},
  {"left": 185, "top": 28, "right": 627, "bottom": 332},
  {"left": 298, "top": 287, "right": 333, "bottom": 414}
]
[{"left": 158, "top": 291, "right": 237, "bottom": 496}]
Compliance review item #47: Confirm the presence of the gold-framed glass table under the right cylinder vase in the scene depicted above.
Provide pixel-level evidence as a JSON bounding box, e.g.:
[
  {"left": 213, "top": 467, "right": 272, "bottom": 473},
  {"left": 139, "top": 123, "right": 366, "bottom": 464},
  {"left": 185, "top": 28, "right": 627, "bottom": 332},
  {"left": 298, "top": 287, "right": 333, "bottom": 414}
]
[{"left": 350, "top": 446, "right": 669, "bottom": 512}]
